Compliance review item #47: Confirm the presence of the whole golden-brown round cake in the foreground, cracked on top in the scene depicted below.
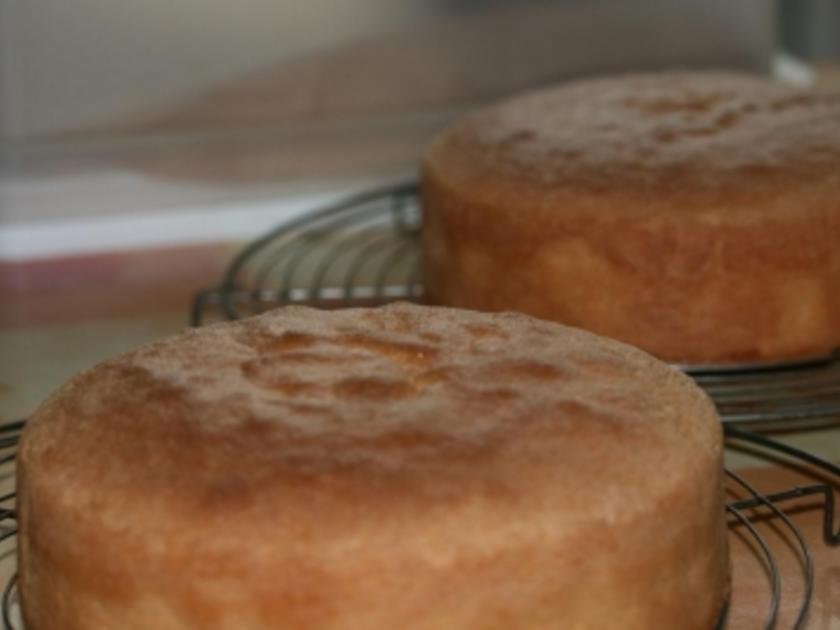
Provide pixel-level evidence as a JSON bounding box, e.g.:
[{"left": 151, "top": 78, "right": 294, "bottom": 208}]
[{"left": 18, "top": 305, "right": 728, "bottom": 630}]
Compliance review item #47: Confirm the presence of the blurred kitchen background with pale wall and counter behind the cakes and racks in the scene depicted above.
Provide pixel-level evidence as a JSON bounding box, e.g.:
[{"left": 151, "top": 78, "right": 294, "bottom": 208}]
[{"left": 0, "top": 0, "right": 840, "bottom": 422}]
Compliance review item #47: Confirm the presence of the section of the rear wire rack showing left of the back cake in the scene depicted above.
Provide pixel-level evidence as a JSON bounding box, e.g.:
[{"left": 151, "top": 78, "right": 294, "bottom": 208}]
[{"left": 191, "top": 183, "right": 423, "bottom": 325}]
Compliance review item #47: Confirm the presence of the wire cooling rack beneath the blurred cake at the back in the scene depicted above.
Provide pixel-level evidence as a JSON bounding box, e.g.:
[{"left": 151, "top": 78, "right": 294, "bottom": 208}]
[{"left": 191, "top": 182, "right": 840, "bottom": 426}]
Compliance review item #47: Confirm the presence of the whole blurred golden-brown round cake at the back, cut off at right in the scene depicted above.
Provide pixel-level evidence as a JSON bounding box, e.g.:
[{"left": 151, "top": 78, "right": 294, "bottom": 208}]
[{"left": 423, "top": 72, "right": 840, "bottom": 363}]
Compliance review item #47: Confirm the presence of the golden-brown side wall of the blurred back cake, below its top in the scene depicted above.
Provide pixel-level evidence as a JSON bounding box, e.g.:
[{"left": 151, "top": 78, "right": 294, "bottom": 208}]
[{"left": 423, "top": 160, "right": 840, "bottom": 363}]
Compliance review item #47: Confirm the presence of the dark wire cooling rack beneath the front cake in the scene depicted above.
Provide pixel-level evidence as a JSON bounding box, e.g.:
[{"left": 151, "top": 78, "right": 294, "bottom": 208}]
[{"left": 0, "top": 422, "right": 840, "bottom": 630}]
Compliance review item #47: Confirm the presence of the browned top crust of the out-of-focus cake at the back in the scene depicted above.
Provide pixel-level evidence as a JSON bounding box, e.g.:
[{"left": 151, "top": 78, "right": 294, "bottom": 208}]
[{"left": 426, "top": 71, "right": 840, "bottom": 205}]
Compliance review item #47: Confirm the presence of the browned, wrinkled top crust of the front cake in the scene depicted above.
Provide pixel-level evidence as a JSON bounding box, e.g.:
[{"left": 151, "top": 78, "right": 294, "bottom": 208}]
[{"left": 21, "top": 304, "right": 721, "bottom": 544}]
